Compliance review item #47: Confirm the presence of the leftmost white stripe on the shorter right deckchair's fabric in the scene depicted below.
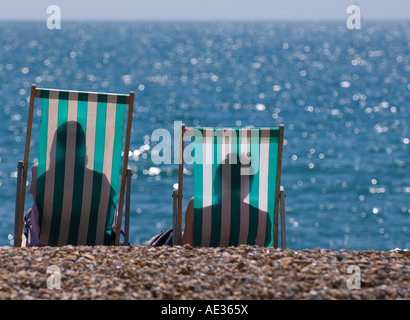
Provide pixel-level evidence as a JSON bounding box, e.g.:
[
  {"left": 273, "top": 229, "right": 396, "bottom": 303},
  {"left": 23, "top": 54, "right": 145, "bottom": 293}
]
[{"left": 201, "top": 129, "right": 213, "bottom": 247}]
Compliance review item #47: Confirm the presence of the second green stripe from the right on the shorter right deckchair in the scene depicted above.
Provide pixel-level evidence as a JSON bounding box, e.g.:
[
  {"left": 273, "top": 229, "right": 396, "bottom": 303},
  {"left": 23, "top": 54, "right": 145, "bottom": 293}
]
[{"left": 247, "top": 129, "right": 260, "bottom": 245}]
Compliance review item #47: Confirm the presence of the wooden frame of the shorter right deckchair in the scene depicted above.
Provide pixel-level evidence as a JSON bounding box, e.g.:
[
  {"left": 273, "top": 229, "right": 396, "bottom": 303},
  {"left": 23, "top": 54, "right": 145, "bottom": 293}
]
[{"left": 172, "top": 124, "right": 286, "bottom": 249}]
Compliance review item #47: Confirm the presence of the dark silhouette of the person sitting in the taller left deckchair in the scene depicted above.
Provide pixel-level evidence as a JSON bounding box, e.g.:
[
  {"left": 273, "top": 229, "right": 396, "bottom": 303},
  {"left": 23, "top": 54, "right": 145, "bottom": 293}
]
[{"left": 27, "top": 121, "right": 116, "bottom": 246}]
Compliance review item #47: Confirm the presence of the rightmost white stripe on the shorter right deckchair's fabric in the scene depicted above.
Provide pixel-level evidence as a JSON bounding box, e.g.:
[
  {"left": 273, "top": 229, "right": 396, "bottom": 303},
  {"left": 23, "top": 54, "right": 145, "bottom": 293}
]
[{"left": 256, "top": 129, "right": 270, "bottom": 246}]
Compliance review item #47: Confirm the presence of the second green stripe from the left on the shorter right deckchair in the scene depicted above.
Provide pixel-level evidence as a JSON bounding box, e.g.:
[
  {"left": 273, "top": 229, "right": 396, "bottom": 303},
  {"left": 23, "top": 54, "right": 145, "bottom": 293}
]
[{"left": 210, "top": 129, "right": 222, "bottom": 247}]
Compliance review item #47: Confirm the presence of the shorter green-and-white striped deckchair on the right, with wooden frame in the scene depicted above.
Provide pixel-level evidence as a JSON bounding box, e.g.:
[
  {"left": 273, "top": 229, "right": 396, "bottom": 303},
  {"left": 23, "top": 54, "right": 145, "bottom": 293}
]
[{"left": 173, "top": 124, "right": 286, "bottom": 249}]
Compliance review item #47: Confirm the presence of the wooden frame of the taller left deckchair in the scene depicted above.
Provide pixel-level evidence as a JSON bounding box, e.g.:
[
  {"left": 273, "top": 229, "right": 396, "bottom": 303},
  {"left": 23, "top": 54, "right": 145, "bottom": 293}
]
[{"left": 14, "top": 84, "right": 135, "bottom": 247}]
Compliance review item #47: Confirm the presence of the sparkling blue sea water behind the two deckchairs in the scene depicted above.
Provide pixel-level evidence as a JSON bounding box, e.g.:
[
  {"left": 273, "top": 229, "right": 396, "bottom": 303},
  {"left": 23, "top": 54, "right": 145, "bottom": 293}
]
[{"left": 0, "top": 21, "right": 410, "bottom": 250}]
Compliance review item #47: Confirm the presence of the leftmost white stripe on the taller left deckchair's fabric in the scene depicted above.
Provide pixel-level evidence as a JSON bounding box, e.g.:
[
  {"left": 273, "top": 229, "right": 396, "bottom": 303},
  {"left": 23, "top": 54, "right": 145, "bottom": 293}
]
[{"left": 40, "top": 91, "right": 59, "bottom": 245}]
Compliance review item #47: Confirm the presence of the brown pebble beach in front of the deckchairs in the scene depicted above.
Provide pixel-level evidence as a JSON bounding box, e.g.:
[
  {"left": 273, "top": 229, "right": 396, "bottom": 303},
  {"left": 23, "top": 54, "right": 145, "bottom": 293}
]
[{"left": 0, "top": 245, "right": 410, "bottom": 300}]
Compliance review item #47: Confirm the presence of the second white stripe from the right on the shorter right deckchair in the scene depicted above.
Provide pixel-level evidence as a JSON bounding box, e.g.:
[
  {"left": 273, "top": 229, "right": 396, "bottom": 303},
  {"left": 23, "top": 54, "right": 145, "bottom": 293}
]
[{"left": 239, "top": 129, "right": 251, "bottom": 244}]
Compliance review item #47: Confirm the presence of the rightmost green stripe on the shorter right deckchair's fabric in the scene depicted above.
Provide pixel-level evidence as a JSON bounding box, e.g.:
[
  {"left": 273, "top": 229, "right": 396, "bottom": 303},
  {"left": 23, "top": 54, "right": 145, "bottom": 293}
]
[{"left": 265, "top": 129, "right": 279, "bottom": 247}]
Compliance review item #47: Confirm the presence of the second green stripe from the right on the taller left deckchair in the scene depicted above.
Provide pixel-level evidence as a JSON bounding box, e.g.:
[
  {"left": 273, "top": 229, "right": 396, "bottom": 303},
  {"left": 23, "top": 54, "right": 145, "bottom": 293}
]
[{"left": 87, "top": 95, "right": 107, "bottom": 245}]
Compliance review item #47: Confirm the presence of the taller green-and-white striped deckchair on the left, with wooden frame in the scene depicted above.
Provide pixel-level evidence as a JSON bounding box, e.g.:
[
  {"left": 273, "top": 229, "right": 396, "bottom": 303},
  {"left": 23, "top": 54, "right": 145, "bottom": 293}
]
[{"left": 14, "top": 85, "right": 134, "bottom": 246}]
